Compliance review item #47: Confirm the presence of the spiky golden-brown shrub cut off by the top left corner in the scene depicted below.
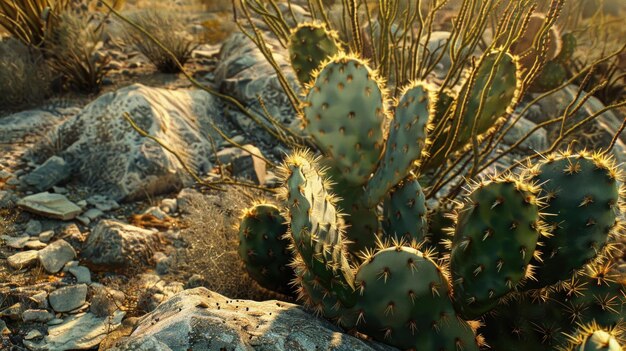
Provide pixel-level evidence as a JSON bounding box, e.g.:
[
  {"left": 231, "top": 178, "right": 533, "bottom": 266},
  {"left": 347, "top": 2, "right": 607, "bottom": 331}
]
[{"left": 0, "top": 0, "right": 69, "bottom": 46}]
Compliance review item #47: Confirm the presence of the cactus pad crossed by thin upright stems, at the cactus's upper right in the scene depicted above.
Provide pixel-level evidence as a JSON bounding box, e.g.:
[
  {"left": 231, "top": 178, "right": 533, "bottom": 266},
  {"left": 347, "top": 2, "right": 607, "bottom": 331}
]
[{"left": 428, "top": 51, "right": 522, "bottom": 168}]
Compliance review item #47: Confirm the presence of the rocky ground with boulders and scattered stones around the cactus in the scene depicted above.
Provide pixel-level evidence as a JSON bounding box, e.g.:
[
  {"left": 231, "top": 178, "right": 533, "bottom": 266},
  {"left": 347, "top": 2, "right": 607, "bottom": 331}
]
[{"left": 0, "top": 0, "right": 626, "bottom": 350}]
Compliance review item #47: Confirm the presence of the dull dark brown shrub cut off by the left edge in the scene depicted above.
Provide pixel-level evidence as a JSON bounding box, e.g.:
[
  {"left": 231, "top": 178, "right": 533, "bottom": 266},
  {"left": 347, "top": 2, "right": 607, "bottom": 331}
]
[{"left": 0, "top": 39, "right": 50, "bottom": 111}]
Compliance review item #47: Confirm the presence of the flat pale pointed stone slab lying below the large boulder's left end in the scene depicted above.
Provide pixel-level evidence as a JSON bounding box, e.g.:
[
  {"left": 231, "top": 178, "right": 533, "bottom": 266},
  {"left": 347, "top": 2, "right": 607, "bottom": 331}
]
[{"left": 17, "top": 193, "right": 81, "bottom": 221}]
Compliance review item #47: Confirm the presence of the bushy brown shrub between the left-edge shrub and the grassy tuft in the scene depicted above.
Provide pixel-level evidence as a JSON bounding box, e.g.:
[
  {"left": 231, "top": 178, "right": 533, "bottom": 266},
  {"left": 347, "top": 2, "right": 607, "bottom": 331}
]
[{"left": 45, "top": 14, "right": 109, "bottom": 93}]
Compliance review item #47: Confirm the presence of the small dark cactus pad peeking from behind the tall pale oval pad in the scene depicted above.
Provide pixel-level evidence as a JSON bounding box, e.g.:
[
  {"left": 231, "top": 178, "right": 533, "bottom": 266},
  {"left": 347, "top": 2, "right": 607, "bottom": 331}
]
[{"left": 288, "top": 23, "right": 340, "bottom": 86}]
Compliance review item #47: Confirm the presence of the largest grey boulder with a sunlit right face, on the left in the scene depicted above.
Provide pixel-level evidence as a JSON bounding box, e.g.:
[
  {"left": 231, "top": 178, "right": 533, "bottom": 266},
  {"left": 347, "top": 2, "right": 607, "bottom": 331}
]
[{"left": 31, "top": 84, "right": 227, "bottom": 201}]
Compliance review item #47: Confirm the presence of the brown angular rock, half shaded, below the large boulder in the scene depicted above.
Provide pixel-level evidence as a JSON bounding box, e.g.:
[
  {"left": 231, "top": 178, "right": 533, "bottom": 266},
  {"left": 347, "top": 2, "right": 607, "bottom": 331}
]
[{"left": 82, "top": 219, "right": 160, "bottom": 265}]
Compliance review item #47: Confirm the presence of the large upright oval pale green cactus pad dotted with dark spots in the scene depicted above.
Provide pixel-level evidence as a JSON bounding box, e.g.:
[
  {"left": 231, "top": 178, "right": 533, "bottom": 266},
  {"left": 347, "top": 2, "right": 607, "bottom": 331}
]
[{"left": 302, "top": 54, "right": 387, "bottom": 186}]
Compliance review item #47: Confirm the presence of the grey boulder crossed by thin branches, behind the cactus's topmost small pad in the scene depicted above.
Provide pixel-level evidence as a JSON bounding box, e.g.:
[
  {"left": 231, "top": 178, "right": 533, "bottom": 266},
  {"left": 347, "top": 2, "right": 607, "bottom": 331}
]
[{"left": 213, "top": 33, "right": 299, "bottom": 144}]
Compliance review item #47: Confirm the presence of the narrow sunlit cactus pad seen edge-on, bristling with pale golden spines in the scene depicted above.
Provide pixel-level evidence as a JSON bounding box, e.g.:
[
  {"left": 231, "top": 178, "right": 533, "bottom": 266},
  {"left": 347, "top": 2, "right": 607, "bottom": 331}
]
[{"left": 280, "top": 152, "right": 354, "bottom": 306}]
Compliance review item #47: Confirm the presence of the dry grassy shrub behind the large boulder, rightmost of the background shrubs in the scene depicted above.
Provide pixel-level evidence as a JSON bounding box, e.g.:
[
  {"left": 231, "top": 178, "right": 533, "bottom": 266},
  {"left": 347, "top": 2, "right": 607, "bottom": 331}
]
[{"left": 125, "top": 10, "right": 196, "bottom": 73}]
